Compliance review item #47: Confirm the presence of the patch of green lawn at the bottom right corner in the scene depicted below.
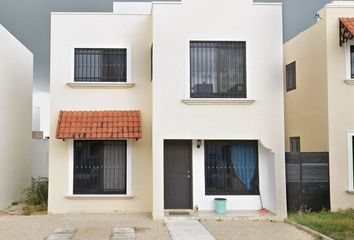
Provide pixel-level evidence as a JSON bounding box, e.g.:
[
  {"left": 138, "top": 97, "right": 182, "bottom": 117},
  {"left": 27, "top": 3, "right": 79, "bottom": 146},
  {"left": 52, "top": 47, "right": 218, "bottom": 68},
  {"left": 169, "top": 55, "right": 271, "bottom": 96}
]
[{"left": 289, "top": 209, "right": 354, "bottom": 240}]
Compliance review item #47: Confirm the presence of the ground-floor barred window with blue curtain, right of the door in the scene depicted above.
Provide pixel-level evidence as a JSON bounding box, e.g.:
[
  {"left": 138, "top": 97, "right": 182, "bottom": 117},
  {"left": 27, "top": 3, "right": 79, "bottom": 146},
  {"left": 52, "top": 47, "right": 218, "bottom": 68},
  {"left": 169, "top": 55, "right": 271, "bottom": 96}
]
[{"left": 205, "top": 140, "right": 259, "bottom": 195}]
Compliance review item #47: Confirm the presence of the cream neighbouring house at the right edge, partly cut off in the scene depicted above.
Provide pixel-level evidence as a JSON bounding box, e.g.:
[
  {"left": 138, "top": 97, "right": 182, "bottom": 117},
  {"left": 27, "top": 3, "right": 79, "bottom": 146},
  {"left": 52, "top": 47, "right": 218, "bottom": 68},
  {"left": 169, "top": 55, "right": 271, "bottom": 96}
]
[{"left": 284, "top": 1, "right": 354, "bottom": 211}]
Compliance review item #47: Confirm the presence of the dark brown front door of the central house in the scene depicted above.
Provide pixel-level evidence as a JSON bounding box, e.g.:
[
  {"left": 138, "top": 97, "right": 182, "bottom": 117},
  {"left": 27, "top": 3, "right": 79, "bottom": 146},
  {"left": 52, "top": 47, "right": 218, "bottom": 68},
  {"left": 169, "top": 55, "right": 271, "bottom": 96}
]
[{"left": 164, "top": 140, "right": 192, "bottom": 209}]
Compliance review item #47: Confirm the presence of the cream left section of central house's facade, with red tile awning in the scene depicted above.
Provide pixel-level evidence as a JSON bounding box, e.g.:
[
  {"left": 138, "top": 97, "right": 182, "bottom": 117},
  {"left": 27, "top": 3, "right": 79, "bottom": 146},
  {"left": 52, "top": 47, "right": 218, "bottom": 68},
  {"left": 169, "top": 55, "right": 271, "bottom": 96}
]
[{"left": 48, "top": 6, "right": 152, "bottom": 213}]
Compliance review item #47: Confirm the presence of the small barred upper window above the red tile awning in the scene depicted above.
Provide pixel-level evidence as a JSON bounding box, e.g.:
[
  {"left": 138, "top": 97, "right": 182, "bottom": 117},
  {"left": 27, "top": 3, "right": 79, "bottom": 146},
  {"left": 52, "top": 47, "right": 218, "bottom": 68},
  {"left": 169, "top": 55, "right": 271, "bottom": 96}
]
[{"left": 74, "top": 48, "right": 127, "bottom": 82}]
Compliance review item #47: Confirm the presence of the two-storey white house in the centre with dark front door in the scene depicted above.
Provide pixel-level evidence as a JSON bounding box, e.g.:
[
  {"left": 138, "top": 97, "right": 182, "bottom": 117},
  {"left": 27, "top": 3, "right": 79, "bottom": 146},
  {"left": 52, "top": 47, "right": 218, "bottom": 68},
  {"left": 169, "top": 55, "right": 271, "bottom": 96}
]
[{"left": 49, "top": 0, "right": 286, "bottom": 219}]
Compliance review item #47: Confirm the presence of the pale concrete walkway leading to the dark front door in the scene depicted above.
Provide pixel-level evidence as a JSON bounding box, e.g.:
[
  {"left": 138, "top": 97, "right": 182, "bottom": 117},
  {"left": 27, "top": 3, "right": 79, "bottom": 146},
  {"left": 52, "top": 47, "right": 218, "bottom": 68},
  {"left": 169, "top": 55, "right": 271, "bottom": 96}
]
[{"left": 165, "top": 219, "right": 215, "bottom": 240}]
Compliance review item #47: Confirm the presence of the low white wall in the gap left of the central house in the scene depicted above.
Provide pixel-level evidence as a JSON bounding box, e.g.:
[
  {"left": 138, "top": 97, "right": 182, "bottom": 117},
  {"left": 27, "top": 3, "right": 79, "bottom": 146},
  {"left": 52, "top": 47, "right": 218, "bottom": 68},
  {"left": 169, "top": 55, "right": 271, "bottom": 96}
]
[{"left": 31, "top": 139, "right": 49, "bottom": 178}]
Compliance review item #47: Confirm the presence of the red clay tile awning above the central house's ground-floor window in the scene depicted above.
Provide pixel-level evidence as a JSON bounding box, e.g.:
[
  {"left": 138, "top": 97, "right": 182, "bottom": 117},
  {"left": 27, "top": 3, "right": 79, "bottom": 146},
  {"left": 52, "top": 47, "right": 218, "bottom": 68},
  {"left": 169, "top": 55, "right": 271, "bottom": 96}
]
[{"left": 56, "top": 111, "right": 142, "bottom": 140}]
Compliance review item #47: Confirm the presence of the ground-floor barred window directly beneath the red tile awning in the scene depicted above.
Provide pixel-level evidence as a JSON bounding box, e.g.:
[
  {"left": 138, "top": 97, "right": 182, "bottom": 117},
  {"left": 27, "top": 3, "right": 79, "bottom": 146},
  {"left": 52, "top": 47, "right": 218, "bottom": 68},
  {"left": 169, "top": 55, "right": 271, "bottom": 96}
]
[{"left": 74, "top": 140, "right": 127, "bottom": 194}]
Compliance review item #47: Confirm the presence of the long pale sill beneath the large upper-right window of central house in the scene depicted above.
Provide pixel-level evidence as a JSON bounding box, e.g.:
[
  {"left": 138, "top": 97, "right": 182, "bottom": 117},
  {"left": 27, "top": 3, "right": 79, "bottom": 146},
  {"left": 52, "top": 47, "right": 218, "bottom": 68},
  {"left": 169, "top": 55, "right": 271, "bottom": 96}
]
[{"left": 182, "top": 98, "right": 255, "bottom": 105}]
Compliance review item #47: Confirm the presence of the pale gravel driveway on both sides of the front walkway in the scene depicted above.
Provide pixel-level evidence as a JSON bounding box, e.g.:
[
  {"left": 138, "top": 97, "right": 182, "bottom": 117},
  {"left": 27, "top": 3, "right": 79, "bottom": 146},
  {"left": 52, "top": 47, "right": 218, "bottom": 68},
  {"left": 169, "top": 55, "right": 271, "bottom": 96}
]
[{"left": 0, "top": 214, "right": 313, "bottom": 240}]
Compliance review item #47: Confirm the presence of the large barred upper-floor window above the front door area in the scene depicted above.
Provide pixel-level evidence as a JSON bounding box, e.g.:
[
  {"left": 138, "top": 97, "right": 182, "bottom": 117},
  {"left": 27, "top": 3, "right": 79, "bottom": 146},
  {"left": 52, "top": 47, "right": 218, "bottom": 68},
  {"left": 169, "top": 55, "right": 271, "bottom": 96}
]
[{"left": 190, "top": 41, "right": 247, "bottom": 98}]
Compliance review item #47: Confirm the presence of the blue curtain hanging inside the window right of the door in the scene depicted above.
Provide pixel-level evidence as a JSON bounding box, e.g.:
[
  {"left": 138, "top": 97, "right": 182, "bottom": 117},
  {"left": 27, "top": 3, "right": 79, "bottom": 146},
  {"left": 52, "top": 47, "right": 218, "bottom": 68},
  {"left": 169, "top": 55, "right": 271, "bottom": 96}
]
[{"left": 231, "top": 142, "right": 258, "bottom": 190}]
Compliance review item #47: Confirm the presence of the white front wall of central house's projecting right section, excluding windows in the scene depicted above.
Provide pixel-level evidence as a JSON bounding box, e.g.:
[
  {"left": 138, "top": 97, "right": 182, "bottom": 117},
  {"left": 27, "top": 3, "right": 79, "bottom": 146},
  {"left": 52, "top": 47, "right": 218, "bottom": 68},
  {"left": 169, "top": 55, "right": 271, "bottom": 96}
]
[{"left": 153, "top": 0, "right": 286, "bottom": 218}]
